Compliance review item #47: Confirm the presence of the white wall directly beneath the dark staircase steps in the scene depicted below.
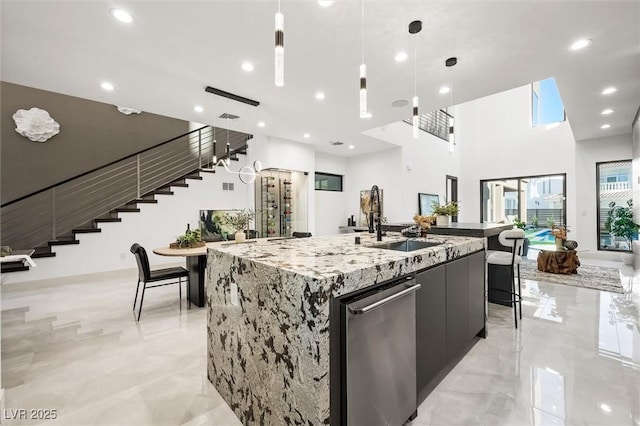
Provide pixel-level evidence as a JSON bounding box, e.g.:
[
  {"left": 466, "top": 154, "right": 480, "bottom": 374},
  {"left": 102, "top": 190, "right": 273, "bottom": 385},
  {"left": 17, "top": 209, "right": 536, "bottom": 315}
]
[{"left": 8, "top": 160, "right": 253, "bottom": 283}]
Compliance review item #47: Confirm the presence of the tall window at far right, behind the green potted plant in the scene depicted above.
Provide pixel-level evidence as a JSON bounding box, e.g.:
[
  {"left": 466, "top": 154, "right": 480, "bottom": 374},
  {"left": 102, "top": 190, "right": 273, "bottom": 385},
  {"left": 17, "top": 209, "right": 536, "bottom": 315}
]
[{"left": 596, "top": 160, "right": 633, "bottom": 251}]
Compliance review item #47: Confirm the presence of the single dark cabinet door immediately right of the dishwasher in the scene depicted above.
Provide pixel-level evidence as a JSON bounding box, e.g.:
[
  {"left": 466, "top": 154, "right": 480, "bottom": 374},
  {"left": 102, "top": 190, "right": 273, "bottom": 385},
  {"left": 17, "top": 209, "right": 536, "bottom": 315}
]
[{"left": 416, "top": 265, "right": 447, "bottom": 401}]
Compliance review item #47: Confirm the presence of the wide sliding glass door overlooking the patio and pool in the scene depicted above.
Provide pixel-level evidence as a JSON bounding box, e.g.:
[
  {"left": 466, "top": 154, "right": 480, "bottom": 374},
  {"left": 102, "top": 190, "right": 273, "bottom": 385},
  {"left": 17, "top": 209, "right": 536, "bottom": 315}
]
[{"left": 480, "top": 174, "right": 567, "bottom": 246}]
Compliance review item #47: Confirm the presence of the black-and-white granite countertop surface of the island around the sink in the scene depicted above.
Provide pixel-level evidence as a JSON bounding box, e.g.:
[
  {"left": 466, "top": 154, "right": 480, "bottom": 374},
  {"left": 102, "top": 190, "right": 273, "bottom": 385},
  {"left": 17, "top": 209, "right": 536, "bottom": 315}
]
[{"left": 208, "top": 232, "right": 484, "bottom": 279}]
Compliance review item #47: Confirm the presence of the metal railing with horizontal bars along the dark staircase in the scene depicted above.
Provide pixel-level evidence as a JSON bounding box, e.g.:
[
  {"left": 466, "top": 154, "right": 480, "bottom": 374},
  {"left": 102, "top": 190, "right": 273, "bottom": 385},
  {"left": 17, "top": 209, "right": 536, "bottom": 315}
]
[{"left": 0, "top": 126, "right": 252, "bottom": 249}]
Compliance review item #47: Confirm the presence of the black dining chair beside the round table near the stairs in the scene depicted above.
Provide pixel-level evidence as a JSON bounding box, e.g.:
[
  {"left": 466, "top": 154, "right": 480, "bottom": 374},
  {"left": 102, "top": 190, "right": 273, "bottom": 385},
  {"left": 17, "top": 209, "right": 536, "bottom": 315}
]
[{"left": 130, "top": 243, "right": 190, "bottom": 321}]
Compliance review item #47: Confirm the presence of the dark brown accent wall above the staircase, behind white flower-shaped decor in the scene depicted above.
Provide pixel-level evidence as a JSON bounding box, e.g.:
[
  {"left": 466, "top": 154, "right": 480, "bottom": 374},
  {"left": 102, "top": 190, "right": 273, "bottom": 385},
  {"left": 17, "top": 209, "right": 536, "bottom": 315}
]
[{"left": 0, "top": 82, "right": 189, "bottom": 203}]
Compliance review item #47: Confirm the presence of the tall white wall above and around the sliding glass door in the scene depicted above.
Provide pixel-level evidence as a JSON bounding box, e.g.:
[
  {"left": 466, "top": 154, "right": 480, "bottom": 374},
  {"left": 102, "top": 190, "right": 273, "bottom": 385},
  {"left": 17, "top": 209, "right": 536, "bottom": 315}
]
[{"left": 456, "top": 86, "right": 580, "bottom": 233}]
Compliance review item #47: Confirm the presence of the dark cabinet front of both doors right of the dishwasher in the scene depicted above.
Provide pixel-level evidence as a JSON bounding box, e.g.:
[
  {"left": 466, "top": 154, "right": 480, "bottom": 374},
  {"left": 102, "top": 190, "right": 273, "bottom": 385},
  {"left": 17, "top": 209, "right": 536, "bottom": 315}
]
[{"left": 416, "top": 251, "right": 485, "bottom": 404}]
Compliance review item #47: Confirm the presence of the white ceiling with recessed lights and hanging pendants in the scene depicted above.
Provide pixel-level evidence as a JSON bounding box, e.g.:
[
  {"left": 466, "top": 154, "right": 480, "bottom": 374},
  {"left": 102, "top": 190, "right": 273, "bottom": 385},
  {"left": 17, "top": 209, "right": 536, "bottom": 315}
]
[{"left": 1, "top": 0, "right": 640, "bottom": 156}]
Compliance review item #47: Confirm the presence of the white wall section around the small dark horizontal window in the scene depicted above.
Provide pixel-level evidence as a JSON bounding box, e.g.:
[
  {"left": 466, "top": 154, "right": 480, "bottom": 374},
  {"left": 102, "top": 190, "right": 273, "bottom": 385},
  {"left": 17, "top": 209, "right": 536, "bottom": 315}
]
[{"left": 310, "top": 152, "right": 348, "bottom": 235}]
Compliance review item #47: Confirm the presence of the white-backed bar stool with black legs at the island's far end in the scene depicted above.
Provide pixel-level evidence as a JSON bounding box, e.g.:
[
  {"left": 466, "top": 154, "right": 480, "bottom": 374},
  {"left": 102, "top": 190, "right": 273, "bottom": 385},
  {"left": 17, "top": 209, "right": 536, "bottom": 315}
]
[{"left": 486, "top": 229, "right": 524, "bottom": 328}]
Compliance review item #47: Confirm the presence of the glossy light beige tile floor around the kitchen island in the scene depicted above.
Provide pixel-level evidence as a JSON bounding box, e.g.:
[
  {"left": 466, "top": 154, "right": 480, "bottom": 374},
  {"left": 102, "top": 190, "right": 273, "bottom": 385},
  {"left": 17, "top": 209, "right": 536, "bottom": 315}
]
[{"left": 0, "top": 261, "right": 640, "bottom": 426}]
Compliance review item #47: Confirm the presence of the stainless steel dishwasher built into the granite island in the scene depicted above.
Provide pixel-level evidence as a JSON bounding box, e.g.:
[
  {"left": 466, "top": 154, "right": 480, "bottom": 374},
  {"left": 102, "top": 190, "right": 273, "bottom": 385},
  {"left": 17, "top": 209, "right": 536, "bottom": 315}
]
[{"left": 341, "top": 277, "right": 420, "bottom": 426}]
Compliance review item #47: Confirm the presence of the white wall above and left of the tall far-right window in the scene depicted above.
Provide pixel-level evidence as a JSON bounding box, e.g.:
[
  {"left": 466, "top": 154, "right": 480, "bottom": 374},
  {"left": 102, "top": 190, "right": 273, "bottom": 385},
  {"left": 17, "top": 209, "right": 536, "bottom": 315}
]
[{"left": 569, "top": 134, "right": 632, "bottom": 260}]
